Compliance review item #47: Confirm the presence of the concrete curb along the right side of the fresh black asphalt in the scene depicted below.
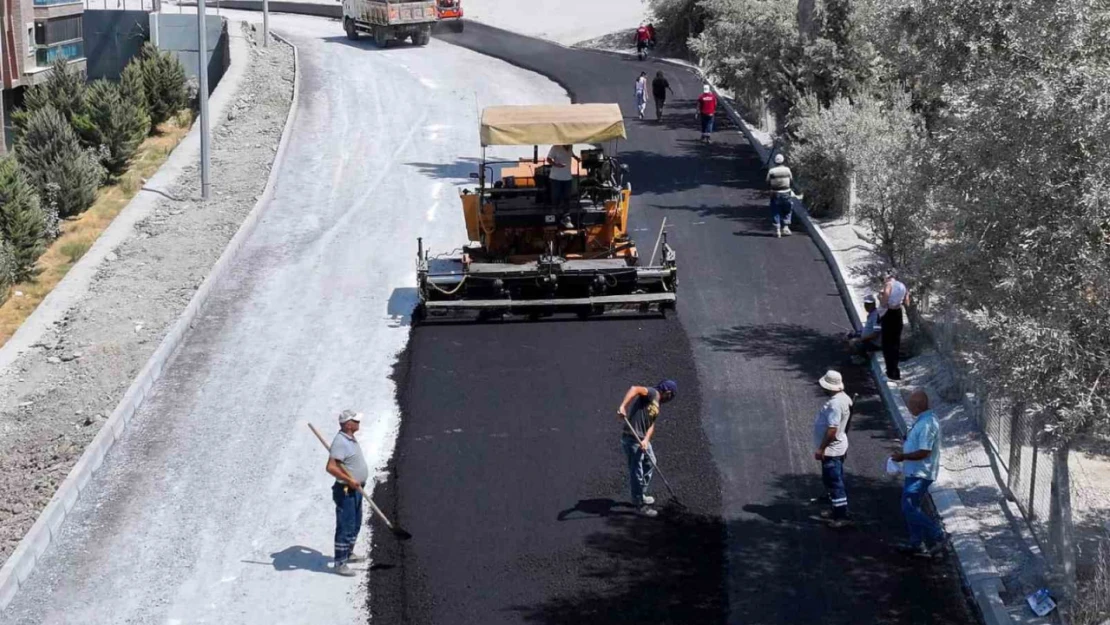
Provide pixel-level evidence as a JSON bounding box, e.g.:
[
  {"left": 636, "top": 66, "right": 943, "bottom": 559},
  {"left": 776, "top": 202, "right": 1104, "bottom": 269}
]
[{"left": 710, "top": 79, "right": 1013, "bottom": 625}]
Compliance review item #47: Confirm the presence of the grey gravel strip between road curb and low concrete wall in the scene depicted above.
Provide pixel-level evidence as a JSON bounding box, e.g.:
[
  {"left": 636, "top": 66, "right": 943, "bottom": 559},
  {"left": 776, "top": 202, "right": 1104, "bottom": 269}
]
[{"left": 0, "top": 24, "right": 293, "bottom": 563}]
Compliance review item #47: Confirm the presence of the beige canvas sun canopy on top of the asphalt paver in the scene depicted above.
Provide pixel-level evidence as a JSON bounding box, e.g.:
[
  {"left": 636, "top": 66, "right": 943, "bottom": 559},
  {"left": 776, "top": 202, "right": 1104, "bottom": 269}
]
[{"left": 482, "top": 104, "right": 625, "bottom": 147}]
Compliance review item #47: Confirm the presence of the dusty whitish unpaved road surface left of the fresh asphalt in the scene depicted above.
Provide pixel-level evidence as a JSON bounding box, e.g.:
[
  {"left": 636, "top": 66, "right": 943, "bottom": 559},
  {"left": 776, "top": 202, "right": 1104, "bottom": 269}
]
[{"left": 0, "top": 11, "right": 566, "bottom": 625}]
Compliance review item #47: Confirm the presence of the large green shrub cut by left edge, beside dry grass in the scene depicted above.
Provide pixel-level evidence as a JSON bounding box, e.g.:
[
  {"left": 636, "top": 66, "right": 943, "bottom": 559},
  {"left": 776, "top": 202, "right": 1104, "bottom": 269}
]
[{"left": 0, "top": 157, "right": 50, "bottom": 282}]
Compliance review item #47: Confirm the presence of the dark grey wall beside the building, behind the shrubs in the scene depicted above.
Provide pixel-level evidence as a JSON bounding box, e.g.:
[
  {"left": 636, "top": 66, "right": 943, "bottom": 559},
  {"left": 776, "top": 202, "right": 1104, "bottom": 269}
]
[{"left": 83, "top": 9, "right": 150, "bottom": 80}]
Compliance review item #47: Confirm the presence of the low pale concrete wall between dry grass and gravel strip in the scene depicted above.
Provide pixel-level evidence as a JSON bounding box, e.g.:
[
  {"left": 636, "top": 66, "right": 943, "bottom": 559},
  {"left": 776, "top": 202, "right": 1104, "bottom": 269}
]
[{"left": 0, "top": 20, "right": 246, "bottom": 374}]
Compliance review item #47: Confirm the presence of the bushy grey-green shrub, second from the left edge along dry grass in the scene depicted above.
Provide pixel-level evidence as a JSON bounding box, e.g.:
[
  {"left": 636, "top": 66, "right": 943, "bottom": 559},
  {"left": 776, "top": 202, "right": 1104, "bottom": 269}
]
[{"left": 16, "top": 107, "right": 104, "bottom": 219}]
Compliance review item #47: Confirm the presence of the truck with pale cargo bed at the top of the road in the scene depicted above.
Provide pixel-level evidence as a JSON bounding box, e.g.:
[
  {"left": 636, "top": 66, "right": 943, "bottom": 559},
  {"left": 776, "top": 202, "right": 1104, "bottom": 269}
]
[{"left": 343, "top": 0, "right": 438, "bottom": 48}]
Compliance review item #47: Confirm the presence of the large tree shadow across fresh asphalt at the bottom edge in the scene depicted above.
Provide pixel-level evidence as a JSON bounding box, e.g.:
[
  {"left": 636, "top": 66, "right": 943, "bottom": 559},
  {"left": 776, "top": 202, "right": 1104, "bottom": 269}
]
[{"left": 509, "top": 472, "right": 973, "bottom": 625}]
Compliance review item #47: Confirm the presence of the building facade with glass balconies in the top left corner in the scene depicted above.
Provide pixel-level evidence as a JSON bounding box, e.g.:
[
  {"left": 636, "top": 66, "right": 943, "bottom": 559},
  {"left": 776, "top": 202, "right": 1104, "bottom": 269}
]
[{"left": 0, "top": 0, "right": 85, "bottom": 148}]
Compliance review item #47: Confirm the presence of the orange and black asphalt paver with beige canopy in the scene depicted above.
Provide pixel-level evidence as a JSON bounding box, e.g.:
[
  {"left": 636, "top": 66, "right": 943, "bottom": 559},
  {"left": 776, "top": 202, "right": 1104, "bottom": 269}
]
[{"left": 412, "top": 104, "right": 678, "bottom": 323}]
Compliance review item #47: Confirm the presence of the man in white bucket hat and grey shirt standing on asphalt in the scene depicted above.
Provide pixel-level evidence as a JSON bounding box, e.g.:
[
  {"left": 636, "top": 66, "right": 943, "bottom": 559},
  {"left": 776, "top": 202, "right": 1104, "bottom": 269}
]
[{"left": 814, "top": 370, "right": 851, "bottom": 528}]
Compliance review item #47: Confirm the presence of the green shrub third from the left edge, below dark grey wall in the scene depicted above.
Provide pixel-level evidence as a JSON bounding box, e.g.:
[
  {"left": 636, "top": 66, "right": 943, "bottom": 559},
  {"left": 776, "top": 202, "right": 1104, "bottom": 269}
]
[{"left": 78, "top": 80, "right": 150, "bottom": 178}]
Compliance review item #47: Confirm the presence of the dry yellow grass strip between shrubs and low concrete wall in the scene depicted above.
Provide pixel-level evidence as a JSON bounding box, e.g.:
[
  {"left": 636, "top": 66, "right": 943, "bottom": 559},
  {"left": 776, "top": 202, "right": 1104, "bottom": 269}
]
[{"left": 0, "top": 111, "right": 193, "bottom": 346}]
